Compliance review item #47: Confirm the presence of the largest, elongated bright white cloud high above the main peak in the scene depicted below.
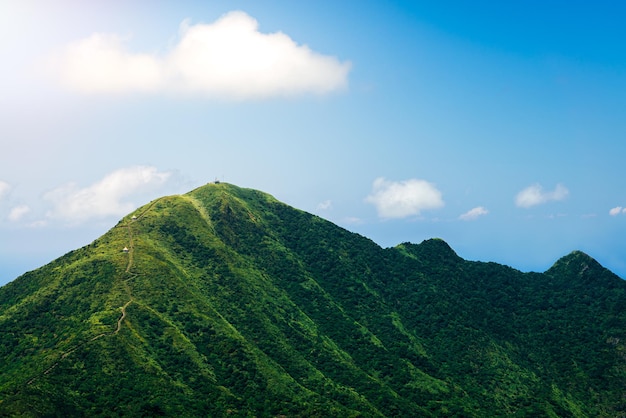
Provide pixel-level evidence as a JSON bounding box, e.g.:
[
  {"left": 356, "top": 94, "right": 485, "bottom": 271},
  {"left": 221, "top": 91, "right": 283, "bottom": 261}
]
[{"left": 60, "top": 11, "right": 351, "bottom": 100}]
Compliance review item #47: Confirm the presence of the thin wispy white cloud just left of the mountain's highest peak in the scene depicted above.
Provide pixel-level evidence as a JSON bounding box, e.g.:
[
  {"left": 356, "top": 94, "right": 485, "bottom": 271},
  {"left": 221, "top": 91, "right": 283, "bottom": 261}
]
[{"left": 44, "top": 166, "right": 171, "bottom": 222}]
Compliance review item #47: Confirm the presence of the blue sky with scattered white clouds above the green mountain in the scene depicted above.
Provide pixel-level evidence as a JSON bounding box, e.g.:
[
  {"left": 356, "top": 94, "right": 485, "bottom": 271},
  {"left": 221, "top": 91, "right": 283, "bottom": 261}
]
[{"left": 0, "top": 0, "right": 626, "bottom": 285}]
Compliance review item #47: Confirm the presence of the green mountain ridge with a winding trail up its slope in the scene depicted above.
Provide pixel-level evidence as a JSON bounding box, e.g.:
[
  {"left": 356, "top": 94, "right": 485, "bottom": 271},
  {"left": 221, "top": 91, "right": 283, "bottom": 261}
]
[{"left": 0, "top": 183, "right": 626, "bottom": 417}]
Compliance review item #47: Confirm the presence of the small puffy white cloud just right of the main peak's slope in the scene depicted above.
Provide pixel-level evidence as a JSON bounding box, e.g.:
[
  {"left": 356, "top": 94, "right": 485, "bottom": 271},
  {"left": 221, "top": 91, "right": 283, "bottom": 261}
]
[{"left": 366, "top": 177, "right": 444, "bottom": 218}]
